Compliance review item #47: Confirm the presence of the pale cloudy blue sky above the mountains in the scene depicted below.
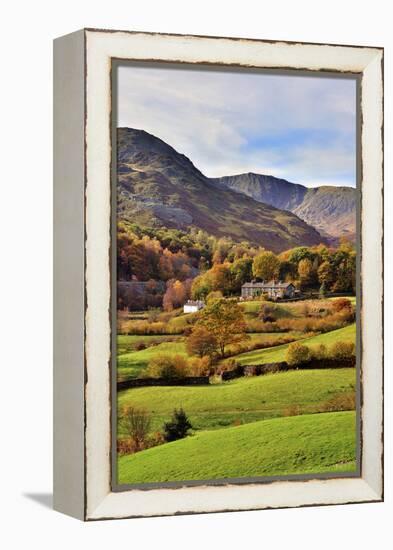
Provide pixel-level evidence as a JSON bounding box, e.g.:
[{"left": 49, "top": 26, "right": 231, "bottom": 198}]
[{"left": 117, "top": 65, "right": 356, "bottom": 187}]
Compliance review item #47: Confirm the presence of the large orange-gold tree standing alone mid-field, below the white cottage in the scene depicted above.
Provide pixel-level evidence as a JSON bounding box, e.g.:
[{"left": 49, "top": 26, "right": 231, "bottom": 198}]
[{"left": 197, "top": 298, "right": 246, "bottom": 357}]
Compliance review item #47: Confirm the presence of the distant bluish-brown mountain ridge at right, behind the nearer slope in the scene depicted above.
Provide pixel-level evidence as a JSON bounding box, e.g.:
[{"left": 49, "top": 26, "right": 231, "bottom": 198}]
[{"left": 212, "top": 172, "right": 356, "bottom": 239}]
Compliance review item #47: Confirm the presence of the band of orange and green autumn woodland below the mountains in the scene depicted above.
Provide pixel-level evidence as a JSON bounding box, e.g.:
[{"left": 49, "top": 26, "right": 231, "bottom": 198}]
[{"left": 117, "top": 222, "right": 356, "bottom": 311}]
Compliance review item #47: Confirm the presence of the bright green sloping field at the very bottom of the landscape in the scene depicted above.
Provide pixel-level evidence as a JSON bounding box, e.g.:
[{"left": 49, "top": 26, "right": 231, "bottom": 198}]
[{"left": 118, "top": 412, "right": 356, "bottom": 483}]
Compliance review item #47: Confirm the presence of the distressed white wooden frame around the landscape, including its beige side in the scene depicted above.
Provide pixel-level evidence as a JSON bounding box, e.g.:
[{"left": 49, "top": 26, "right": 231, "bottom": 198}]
[{"left": 54, "top": 29, "right": 383, "bottom": 520}]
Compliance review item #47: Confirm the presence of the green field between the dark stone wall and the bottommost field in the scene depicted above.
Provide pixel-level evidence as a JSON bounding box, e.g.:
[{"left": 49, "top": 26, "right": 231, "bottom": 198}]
[{"left": 118, "top": 369, "right": 356, "bottom": 437}]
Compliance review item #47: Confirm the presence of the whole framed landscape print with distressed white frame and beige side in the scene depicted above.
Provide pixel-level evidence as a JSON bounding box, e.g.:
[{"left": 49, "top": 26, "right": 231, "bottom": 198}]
[{"left": 54, "top": 29, "right": 383, "bottom": 520}]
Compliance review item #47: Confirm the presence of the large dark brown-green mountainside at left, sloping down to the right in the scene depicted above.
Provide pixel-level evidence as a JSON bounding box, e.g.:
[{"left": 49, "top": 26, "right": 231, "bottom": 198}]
[{"left": 117, "top": 128, "right": 324, "bottom": 252}]
